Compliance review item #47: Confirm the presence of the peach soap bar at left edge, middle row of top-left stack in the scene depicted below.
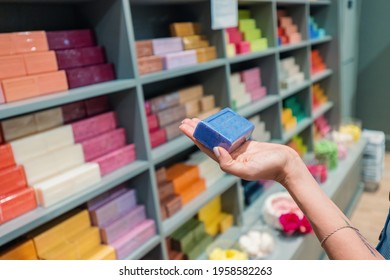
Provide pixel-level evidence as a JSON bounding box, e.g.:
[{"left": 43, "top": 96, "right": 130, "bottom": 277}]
[{"left": 0, "top": 54, "right": 27, "bottom": 80}]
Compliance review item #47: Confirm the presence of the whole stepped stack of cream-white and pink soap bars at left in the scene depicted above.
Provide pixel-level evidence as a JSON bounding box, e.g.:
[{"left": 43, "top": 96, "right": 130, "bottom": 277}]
[{"left": 1, "top": 96, "right": 136, "bottom": 211}]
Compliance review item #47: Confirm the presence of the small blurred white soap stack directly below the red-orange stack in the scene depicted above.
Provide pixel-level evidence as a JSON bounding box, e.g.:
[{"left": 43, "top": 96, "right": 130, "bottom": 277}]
[{"left": 279, "top": 56, "right": 305, "bottom": 89}]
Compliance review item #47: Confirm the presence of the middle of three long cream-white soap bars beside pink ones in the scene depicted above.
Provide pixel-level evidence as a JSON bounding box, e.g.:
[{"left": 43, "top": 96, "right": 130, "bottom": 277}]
[{"left": 23, "top": 145, "right": 85, "bottom": 185}]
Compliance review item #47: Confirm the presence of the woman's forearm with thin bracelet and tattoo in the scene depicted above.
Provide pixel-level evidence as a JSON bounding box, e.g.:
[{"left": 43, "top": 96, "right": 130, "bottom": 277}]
[{"left": 281, "top": 153, "right": 383, "bottom": 259}]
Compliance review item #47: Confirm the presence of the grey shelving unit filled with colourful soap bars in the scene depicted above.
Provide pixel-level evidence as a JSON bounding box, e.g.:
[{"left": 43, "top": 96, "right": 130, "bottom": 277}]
[{"left": 0, "top": 0, "right": 363, "bottom": 259}]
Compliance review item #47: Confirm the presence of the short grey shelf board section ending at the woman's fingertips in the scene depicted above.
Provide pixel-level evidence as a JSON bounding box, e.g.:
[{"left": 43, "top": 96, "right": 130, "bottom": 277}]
[{"left": 152, "top": 135, "right": 194, "bottom": 164}]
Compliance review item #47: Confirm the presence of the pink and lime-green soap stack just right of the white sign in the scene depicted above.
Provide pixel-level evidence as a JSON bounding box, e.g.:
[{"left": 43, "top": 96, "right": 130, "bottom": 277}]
[{"left": 225, "top": 10, "right": 268, "bottom": 57}]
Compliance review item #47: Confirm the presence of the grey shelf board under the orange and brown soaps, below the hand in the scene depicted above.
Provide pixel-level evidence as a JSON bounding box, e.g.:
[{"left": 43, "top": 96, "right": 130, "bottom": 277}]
[{"left": 162, "top": 175, "right": 239, "bottom": 237}]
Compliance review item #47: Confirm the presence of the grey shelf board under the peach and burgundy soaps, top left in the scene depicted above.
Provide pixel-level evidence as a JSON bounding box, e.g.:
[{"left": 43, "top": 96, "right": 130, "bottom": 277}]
[{"left": 0, "top": 79, "right": 136, "bottom": 119}]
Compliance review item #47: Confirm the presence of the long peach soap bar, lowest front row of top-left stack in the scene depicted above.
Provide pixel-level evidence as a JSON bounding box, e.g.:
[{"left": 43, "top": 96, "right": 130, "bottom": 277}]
[{"left": 2, "top": 71, "right": 68, "bottom": 102}]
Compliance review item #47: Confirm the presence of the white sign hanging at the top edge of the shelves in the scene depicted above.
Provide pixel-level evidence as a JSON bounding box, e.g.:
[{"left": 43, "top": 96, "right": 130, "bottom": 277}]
[{"left": 211, "top": 0, "right": 238, "bottom": 29}]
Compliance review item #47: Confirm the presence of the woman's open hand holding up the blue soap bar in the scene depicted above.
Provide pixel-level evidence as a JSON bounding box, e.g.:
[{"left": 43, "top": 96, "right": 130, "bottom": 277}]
[{"left": 180, "top": 119, "right": 300, "bottom": 184}]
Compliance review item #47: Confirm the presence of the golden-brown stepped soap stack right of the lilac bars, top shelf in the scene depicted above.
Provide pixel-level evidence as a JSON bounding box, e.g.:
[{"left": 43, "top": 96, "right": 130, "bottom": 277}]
[{"left": 170, "top": 22, "right": 217, "bottom": 63}]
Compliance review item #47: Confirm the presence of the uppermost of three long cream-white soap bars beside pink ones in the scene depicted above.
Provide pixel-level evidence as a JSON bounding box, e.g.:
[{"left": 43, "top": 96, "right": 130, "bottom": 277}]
[{"left": 10, "top": 125, "right": 74, "bottom": 164}]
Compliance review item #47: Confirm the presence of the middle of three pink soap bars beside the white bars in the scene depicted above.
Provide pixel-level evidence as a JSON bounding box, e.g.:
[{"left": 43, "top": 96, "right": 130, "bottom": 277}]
[{"left": 81, "top": 128, "right": 126, "bottom": 161}]
